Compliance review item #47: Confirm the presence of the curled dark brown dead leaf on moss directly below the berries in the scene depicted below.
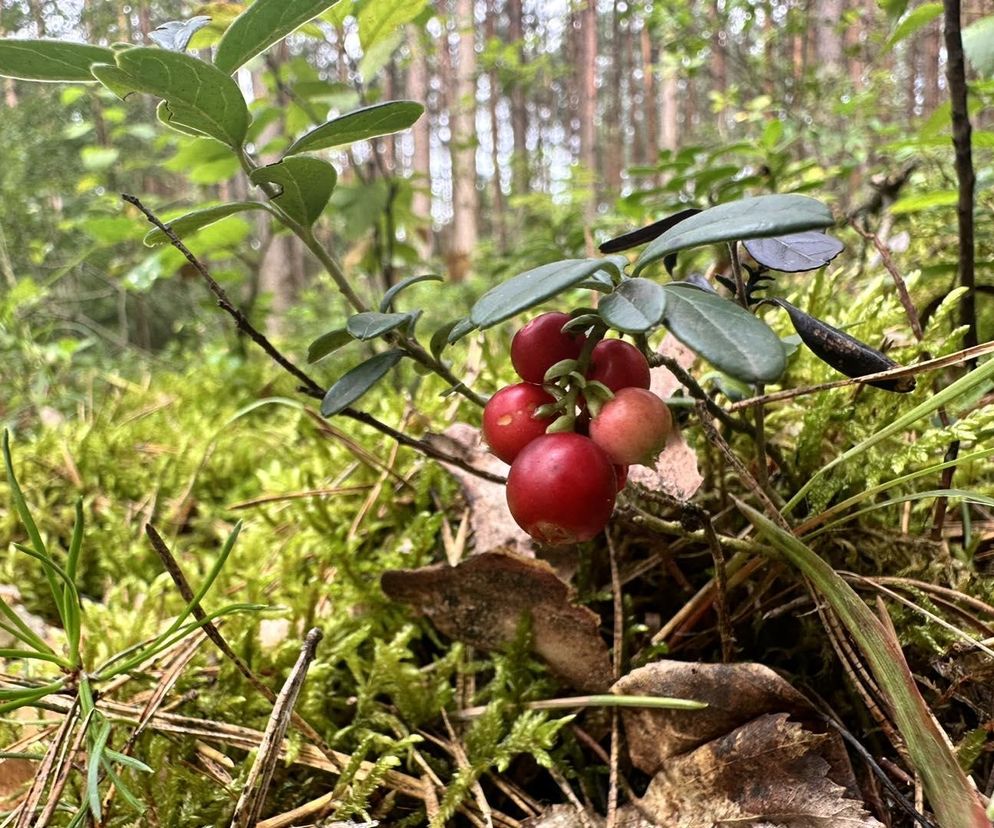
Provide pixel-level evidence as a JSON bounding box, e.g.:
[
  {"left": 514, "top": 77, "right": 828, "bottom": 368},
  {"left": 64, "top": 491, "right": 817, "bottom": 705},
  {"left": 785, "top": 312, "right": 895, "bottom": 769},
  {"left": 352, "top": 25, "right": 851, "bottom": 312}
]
[{"left": 380, "top": 552, "right": 611, "bottom": 692}]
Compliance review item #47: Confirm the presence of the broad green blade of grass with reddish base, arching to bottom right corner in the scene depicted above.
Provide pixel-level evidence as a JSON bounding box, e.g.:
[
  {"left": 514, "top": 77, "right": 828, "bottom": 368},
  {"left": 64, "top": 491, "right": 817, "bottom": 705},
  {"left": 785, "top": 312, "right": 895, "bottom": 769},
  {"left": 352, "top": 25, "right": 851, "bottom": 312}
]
[{"left": 735, "top": 498, "right": 994, "bottom": 828}]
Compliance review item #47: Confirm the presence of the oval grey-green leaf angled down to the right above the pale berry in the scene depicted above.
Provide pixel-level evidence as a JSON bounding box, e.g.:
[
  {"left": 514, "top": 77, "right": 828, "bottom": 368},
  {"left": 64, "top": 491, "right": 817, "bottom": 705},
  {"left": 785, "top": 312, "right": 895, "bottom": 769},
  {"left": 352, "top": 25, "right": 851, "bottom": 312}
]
[{"left": 663, "top": 282, "right": 786, "bottom": 382}]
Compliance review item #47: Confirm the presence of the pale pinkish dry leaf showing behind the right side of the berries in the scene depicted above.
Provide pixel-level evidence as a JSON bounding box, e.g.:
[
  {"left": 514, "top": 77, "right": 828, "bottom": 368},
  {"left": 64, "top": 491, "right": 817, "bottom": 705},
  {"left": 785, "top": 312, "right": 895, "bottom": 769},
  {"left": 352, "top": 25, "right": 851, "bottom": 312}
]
[{"left": 628, "top": 334, "right": 704, "bottom": 500}]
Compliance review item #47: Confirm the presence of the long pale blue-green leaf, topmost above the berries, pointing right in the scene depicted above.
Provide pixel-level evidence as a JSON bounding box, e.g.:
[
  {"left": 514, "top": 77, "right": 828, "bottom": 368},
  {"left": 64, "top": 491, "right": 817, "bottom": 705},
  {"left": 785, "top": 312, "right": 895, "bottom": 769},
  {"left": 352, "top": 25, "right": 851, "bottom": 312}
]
[{"left": 635, "top": 195, "right": 834, "bottom": 274}]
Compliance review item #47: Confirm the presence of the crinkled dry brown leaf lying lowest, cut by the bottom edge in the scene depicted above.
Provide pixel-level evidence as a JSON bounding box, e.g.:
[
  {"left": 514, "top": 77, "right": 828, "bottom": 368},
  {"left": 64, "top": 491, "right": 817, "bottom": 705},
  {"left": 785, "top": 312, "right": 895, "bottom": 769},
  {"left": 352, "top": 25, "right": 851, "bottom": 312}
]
[{"left": 639, "top": 713, "right": 882, "bottom": 828}]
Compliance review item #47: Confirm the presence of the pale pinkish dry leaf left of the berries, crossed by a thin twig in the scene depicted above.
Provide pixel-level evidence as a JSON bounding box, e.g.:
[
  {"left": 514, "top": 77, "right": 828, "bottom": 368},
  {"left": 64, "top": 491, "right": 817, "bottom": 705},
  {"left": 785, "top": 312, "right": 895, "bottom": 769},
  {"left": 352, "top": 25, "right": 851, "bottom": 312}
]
[{"left": 425, "top": 423, "right": 534, "bottom": 558}]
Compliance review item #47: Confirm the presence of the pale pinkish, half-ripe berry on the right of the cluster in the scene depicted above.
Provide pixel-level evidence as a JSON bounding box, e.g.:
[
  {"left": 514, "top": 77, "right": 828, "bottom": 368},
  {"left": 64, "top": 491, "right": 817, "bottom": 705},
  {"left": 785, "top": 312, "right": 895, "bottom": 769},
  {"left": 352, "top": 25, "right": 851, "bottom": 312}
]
[{"left": 590, "top": 388, "right": 673, "bottom": 465}]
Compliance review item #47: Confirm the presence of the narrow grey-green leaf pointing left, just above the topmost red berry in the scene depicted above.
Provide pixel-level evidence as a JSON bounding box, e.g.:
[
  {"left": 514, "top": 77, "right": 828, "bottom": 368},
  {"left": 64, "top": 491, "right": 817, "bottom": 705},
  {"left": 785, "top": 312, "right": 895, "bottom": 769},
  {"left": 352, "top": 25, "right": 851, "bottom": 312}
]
[{"left": 464, "top": 256, "right": 626, "bottom": 328}]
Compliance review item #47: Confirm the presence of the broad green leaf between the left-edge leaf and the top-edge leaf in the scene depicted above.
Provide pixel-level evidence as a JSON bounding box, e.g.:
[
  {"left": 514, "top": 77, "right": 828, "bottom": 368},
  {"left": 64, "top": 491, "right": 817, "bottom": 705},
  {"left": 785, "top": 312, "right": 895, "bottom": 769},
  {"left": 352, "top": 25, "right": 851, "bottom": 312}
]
[{"left": 93, "top": 46, "right": 249, "bottom": 149}]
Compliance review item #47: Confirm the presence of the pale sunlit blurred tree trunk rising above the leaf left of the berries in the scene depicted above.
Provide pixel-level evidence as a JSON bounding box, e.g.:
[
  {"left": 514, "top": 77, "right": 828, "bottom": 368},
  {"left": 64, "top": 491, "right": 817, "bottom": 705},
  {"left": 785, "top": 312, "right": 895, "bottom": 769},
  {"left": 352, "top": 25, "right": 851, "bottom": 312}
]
[{"left": 448, "top": 0, "right": 478, "bottom": 281}]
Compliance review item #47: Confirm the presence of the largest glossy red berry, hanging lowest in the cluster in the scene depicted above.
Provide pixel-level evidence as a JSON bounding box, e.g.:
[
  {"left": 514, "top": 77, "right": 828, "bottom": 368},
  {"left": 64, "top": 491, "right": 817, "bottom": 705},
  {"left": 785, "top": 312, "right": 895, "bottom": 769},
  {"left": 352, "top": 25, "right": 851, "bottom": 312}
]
[{"left": 507, "top": 432, "right": 618, "bottom": 544}]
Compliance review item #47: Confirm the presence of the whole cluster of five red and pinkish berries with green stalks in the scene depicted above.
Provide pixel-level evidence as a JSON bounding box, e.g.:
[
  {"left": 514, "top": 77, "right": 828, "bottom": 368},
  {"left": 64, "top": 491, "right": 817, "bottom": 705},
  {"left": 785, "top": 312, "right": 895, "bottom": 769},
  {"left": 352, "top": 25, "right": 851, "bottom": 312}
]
[{"left": 483, "top": 313, "right": 672, "bottom": 544}]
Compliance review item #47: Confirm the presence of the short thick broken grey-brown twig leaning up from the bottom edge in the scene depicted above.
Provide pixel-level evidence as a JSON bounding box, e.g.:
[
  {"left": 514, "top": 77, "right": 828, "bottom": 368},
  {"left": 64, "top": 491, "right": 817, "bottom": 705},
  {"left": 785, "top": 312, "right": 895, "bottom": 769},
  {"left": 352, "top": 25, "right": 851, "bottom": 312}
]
[{"left": 231, "top": 628, "right": 322, "bottom": 828}]
